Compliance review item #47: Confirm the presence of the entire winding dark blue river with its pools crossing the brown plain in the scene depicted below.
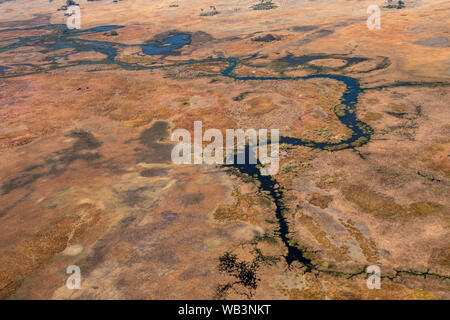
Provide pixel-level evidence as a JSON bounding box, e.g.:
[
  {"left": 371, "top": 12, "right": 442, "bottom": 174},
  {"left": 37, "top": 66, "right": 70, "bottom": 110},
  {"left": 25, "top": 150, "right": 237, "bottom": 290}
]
[{"left": 0, "top": 25, "right": 373, "bottom": 271}]
